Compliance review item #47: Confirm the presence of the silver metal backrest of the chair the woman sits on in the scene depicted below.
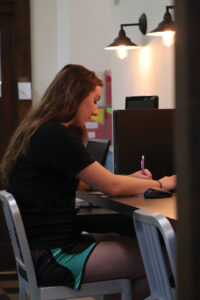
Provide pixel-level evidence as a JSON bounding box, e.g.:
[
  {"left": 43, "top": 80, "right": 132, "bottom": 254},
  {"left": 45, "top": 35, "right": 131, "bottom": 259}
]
[{"left": 0, "top": 191, "right": 38, "bottom": 294}]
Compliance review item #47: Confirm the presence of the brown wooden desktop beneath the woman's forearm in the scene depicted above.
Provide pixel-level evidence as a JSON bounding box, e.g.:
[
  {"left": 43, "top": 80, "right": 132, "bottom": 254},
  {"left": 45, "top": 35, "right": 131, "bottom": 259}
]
[{"left": 77, "top": 191, "right": 178, "bottom": 220}]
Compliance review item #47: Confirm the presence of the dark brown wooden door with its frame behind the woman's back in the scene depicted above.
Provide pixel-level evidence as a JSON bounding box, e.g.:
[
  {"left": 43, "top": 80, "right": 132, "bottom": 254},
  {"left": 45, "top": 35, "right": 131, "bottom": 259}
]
[{"left": 0, "top": 0, "right": 32, "bottom": 271}]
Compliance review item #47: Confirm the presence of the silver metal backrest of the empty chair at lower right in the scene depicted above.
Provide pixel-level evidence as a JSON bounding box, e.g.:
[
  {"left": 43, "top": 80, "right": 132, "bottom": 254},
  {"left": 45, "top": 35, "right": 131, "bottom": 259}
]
[{"left": 133, "top": 209, "right": 177, "bottom": 300}]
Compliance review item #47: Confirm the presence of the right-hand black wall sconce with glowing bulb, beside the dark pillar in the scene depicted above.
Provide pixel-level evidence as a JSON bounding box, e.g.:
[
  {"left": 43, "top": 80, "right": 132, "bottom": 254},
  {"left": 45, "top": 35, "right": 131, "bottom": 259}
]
[{"left": 147, "top": 5, "right": 175, "bottom": 47}]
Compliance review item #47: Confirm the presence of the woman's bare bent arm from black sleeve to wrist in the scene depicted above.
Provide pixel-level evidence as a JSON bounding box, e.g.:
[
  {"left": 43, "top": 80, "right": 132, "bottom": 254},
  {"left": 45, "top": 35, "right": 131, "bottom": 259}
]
[{"left": 76, "top": 161, "right": 164, "bottom": 196}]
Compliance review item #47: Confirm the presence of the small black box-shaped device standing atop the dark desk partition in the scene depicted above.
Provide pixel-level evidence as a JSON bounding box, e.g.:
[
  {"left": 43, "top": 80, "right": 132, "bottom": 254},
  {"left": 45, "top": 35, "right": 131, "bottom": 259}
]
[{"left": 125, "top": 96, "right": 159, "bottom": 109}]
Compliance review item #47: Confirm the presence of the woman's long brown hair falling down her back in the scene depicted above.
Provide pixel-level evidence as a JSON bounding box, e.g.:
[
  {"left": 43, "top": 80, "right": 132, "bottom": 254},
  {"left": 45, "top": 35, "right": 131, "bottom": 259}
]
[{"left": 0, "top": 64, "right": 103, "bottom": 188}]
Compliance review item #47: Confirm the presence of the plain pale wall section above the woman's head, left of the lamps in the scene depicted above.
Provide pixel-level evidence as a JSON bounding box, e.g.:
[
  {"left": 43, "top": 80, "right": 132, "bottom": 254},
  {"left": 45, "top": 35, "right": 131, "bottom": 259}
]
[{"left": 30, "top": 0, "right": 111, "bottom": 103}]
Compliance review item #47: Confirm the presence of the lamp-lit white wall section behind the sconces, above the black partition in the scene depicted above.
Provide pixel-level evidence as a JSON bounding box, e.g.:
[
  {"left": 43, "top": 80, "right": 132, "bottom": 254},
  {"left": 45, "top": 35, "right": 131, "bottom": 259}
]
[{"left": 111, "top": 0, "right": 175, "bottom": 109}]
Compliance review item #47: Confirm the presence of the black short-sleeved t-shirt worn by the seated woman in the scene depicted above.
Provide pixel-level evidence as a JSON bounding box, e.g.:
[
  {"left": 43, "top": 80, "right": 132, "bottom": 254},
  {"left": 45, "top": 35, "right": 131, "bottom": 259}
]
[{"left": 9, "top": 122, "right": 94, "bottom": 250}]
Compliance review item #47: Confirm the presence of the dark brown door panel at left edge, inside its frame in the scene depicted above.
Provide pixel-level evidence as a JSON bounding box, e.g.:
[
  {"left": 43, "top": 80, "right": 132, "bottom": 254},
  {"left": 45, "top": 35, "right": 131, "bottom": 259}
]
[{"left": 0, "top": 8, "right": 17, "bottom": 156}]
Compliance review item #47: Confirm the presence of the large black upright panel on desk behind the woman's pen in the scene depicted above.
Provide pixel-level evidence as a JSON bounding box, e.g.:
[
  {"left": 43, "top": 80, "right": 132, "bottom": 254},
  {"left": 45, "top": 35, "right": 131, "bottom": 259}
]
[{"left": 113, "top": 109, "right": 175, "bottom": 179}]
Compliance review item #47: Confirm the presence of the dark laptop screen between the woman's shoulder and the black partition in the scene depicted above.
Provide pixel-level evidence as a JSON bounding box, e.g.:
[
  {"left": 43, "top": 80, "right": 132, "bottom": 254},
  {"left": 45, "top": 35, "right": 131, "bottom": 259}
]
[{"left": 86, "top": 139, "right": 110, "bottom": 166}]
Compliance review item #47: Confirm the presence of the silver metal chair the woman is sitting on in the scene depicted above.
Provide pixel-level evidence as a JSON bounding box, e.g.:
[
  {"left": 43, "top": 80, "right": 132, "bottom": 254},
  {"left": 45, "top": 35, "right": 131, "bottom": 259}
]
[{"left": 0, "top": 191, "right": 132, "bottom": 300}]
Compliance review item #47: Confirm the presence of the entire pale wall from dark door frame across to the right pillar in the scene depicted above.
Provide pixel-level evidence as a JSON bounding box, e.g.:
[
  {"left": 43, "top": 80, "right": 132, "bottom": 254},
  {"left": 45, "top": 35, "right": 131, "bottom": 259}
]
[{"left": 31, "top": 0, "right": 175, "bottom": 109}]
